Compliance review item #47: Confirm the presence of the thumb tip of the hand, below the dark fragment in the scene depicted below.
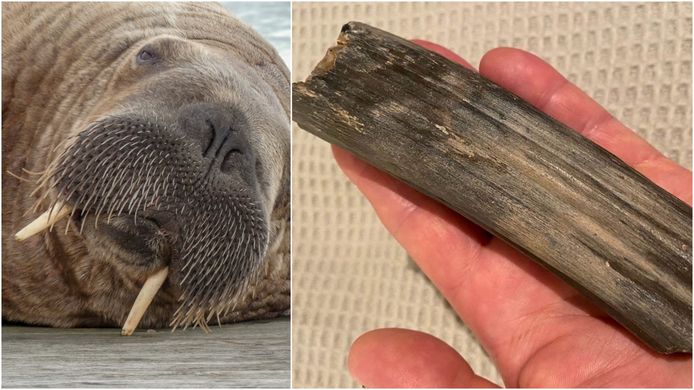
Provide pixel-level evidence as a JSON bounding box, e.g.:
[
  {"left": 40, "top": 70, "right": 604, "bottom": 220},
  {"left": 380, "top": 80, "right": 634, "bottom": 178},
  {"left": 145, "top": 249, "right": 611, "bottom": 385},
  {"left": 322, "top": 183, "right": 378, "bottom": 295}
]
[{"left": 348, "top": 329, "right": 498, "bottom": 388}]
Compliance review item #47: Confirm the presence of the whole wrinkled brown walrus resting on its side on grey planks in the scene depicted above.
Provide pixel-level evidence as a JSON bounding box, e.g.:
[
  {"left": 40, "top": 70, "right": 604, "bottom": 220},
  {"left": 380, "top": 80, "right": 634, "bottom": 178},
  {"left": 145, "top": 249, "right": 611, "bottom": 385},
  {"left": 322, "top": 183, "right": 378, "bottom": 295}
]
[{"left": 2, "top": 3, "right": 290, "bottom": 328}]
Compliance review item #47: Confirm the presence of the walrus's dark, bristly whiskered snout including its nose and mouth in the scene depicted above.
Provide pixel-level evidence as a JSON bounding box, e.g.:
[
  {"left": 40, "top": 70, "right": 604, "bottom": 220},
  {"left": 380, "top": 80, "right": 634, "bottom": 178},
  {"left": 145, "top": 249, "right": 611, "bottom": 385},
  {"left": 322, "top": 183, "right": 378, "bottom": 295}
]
[{"left": 34, "top": 114, "right": 269, "bottom": 326}]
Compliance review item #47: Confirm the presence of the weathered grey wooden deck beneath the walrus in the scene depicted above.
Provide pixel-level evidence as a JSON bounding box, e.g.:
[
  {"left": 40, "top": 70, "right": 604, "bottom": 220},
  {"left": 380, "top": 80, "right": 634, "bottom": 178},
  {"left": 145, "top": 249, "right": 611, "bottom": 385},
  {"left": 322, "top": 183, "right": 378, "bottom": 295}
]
[{"left": 2, "top": 318, "right": 290, "bottom": 388}]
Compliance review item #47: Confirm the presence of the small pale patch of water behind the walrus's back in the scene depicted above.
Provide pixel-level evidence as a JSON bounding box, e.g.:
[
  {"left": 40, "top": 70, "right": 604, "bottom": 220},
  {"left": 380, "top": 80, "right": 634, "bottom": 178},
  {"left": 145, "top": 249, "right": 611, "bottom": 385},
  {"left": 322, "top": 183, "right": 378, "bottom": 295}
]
[{"left": 222, "top": 1, "right": 292, "bottom": 64}]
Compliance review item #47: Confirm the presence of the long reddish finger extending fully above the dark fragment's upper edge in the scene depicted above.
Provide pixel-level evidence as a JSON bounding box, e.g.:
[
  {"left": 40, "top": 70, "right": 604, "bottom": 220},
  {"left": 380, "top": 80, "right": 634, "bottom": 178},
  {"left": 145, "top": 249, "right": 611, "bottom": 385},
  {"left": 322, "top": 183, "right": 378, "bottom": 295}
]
[{"left": 480, "top": 48, "right": 692, "bottom": 204}]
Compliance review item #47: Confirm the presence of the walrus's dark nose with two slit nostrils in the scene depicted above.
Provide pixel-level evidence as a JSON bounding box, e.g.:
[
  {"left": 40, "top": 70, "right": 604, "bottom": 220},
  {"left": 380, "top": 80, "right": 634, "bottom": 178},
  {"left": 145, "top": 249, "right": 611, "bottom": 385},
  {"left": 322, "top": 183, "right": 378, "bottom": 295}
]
[{"left": 179, "top": 103, "right": 254, "bottom": 173}]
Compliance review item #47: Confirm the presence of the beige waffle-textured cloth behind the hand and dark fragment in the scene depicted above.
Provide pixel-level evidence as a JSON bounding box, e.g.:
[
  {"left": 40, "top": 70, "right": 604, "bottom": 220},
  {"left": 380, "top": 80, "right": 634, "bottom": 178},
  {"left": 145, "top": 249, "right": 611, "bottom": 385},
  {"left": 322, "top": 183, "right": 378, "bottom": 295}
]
[{"left": 292, "top": 3, "right": 692, "bottom": 387}]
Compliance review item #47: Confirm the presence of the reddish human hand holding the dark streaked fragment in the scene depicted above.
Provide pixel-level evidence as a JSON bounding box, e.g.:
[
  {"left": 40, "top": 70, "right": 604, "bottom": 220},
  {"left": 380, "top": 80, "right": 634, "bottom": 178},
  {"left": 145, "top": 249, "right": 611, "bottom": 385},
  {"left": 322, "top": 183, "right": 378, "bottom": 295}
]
[{"left": 333, "top": 41, "right": 692, "bottom": 387}]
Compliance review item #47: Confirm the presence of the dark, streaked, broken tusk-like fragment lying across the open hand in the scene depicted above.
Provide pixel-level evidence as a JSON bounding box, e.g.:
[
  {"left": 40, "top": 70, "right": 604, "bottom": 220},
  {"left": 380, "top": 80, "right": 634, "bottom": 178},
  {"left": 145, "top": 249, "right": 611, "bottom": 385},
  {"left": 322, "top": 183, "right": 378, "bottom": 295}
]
[{"left": 293, "top": 22, "right": 692, "bottom": 353}]
